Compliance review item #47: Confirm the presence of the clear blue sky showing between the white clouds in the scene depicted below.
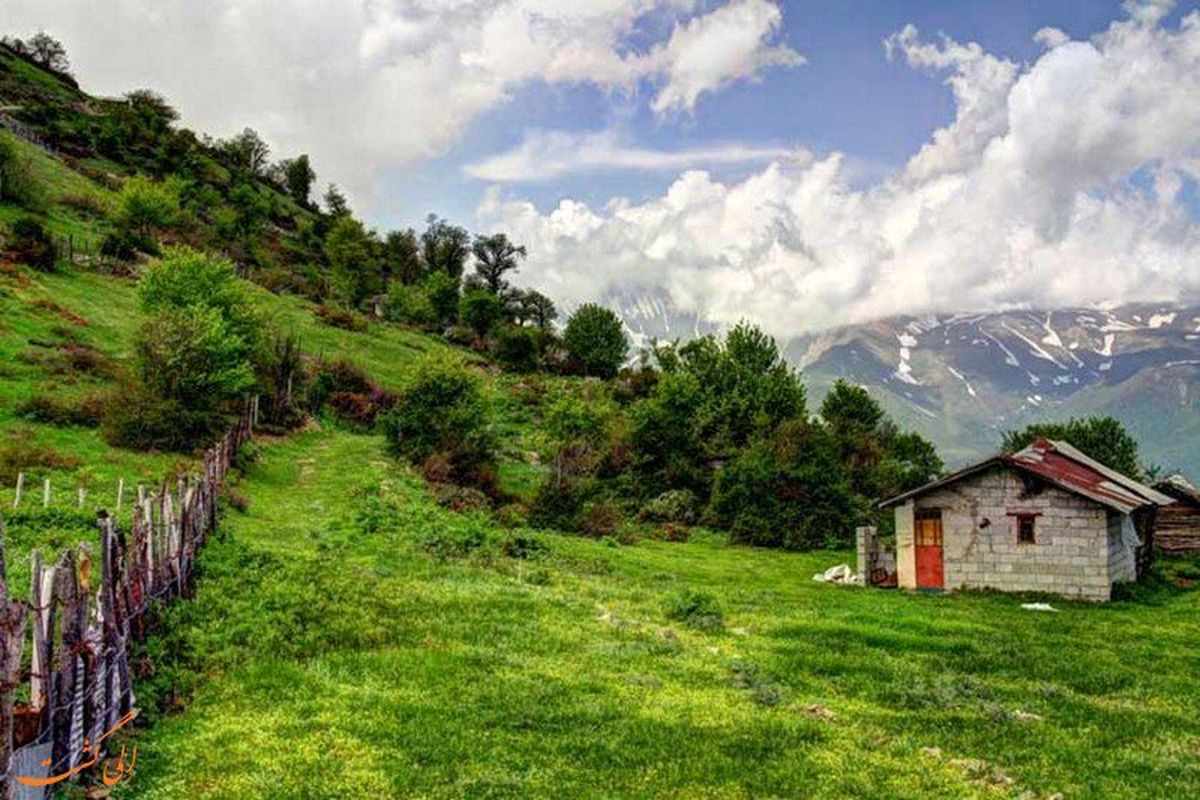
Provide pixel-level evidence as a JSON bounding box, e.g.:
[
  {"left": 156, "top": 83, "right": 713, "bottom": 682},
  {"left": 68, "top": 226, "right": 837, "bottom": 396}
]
[{"left": 388, "top": 0, "right": 1200, "bottom": 227}]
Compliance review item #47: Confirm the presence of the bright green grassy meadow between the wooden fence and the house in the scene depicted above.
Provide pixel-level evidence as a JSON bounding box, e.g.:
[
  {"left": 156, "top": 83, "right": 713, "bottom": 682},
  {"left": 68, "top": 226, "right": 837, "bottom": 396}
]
[{"left": 127, "top": 429, "right": 1200, "bottom": 798}]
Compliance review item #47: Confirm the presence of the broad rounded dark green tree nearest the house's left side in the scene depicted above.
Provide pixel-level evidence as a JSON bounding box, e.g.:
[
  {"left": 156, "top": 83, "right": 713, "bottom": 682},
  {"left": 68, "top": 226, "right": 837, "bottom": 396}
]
[{"left": 710, "top": 420, "right": 856, "bottom": 549}]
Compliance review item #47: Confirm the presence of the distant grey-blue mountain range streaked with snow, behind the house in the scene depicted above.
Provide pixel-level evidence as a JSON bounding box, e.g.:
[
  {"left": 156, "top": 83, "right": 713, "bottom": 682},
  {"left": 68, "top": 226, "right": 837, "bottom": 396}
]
[{"left": 607, "top": 297, "right": 1200, "bottom": 479}]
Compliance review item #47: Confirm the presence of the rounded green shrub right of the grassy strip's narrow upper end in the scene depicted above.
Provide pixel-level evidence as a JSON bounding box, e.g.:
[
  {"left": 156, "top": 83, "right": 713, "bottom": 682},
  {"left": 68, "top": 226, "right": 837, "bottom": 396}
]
[{"left": 380, "top": 359, "right": 496, "bottom": 479}]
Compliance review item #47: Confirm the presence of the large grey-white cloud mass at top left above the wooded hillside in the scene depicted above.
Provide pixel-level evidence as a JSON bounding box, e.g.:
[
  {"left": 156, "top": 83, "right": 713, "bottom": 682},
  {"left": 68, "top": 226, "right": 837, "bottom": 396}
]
[{"left": 4, "top": 0, "right": 798, "bottom": 209}]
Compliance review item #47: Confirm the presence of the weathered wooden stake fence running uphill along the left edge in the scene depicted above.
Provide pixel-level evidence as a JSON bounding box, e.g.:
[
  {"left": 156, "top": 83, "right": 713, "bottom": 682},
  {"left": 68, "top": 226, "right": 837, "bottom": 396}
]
[{"left": 0, "top": 398, "right": 258, "bottom": 799}]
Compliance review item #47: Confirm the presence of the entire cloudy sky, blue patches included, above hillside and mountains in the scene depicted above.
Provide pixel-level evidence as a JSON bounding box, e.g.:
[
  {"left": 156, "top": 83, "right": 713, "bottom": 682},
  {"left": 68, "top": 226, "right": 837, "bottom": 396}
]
[{"left": 7, "top": 0, "right": 1200, "bottom": 336}]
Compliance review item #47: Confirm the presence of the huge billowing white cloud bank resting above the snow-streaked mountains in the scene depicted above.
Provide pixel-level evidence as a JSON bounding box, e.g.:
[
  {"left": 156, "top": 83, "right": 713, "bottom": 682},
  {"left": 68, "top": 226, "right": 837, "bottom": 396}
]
[{"left": 480, "top": 6, "right": 1200, "bottom": 336}]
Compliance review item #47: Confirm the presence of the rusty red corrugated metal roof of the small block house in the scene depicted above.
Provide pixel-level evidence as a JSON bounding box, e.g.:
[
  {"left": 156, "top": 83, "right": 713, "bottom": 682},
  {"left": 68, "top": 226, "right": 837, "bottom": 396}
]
[{"left": 880, "top": 439, "right": 1171, "bottom": 513}]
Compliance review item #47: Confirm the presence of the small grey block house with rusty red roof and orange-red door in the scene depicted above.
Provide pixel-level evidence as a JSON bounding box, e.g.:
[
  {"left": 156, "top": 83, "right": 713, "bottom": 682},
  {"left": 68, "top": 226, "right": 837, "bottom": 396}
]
[{"left": 881, "top": 439, "right": 1170, "bottom": 601}]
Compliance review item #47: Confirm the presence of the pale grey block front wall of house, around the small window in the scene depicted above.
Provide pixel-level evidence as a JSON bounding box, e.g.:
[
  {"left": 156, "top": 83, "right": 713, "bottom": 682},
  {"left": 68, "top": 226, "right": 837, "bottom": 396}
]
[{"left": 898, "top": 467, "right": 1124, "bottom": 600}]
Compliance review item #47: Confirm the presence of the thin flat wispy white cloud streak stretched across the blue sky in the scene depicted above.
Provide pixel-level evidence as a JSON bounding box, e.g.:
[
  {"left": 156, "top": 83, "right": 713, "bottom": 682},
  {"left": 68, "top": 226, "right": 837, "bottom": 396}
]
[{"left": 463, "top": 131, "right": 811, "bottom": 182}]
